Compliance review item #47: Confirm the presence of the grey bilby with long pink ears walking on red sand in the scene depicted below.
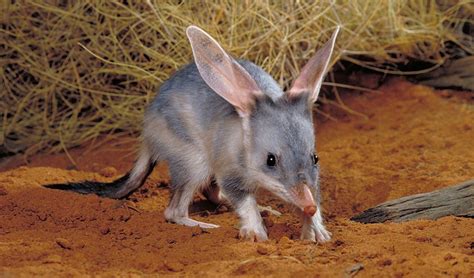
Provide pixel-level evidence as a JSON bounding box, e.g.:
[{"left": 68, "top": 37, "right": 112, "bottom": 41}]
[{"left": 46, "top": 26, "right": 339, "bottom": 242}]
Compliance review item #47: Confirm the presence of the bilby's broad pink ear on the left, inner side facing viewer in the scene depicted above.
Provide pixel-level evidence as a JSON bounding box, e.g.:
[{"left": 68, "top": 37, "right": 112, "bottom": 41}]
[{"left": 186, "top": 26, "right": 263, "bottom": 117}]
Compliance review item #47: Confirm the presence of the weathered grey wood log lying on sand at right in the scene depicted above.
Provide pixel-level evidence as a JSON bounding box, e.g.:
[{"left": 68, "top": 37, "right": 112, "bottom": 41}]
[{"left": 351, "top": 180, "right": 474, "bottom": 223}]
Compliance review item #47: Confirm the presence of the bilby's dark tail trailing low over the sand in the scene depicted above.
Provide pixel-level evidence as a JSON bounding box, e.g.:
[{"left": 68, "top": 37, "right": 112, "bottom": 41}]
[{"left": 44, "top": 152, "right": 156, "bottom": 199}]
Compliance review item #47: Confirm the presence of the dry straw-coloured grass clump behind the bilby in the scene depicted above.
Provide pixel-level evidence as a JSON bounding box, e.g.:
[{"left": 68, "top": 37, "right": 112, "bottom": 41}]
[{"left": 0, "top": 0, "right": 474, "bottom": 153}]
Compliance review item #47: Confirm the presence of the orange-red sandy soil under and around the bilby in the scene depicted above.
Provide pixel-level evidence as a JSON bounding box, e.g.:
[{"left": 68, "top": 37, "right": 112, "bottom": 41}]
[{"left": 0, "top": 80, "right": 474, "bottom": 277}]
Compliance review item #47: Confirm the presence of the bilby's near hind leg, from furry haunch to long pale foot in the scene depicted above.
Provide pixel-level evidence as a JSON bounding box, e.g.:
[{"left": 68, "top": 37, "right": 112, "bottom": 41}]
[{"left": 144, "top": 105, "right": 218, "bottom": 228}]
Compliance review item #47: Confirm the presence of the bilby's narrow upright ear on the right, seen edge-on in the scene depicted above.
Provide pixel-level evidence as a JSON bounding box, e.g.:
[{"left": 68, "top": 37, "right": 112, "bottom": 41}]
[{"left": 288, "top": 26, "right": 340, "bottom": 103}]
